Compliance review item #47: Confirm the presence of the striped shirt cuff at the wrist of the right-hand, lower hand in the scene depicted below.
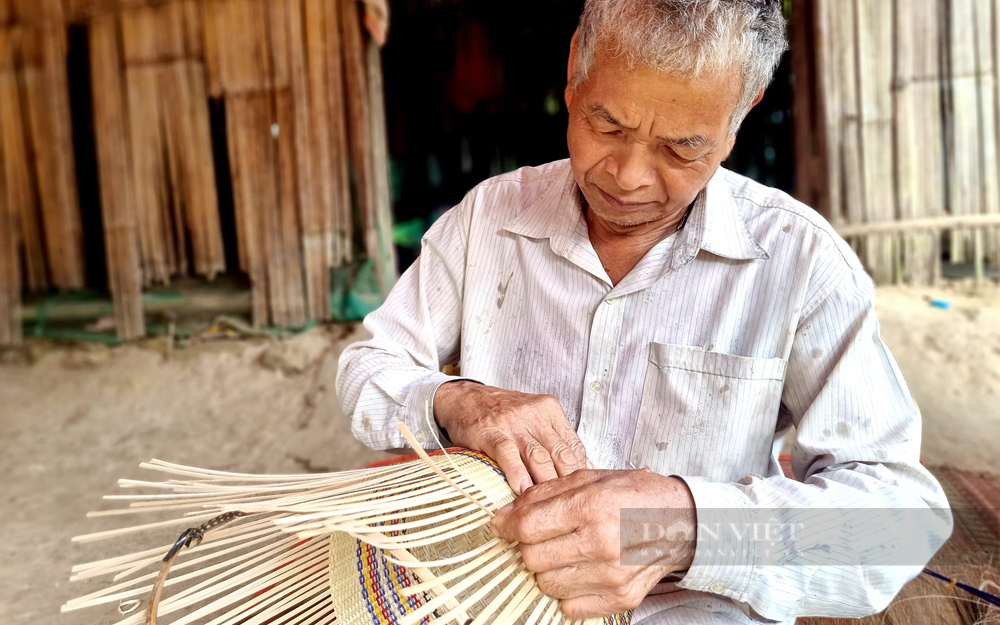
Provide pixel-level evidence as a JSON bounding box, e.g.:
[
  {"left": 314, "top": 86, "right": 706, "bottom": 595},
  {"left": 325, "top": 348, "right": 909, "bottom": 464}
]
[{"left": 672, "top": 475, "right": 757, "bottom": 602}]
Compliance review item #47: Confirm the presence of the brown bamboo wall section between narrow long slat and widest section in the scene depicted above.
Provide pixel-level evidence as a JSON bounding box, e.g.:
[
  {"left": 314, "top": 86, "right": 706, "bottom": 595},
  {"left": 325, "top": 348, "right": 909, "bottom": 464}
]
[{"left": 119, "top": 0, "right": 225, "bottom": 285}]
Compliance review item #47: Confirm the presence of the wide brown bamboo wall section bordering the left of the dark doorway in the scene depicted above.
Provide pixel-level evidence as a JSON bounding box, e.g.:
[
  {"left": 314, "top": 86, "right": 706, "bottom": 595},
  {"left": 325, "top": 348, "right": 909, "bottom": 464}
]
[{"left": 201, "top": 0, "right": 395, "bottom": 325}]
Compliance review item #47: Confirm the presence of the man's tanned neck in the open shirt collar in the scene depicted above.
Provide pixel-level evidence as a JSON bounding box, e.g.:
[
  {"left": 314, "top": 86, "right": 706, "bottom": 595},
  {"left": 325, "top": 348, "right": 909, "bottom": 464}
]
[{"left": 583, "top": 199, "right": 693, "bottom": 285}]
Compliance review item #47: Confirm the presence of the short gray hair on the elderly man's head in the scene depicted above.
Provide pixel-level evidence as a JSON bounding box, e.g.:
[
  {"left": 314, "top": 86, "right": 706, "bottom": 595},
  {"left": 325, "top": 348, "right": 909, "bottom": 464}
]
[{"left": 571, "top": 0, "right": 788, "bottom": 134}]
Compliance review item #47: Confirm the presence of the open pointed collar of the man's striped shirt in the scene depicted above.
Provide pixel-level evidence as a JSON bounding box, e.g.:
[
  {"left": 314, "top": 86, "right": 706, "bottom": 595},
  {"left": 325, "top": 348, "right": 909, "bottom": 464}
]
[{"left": 504, "top": 161, "right": 769, "bottom": 269}]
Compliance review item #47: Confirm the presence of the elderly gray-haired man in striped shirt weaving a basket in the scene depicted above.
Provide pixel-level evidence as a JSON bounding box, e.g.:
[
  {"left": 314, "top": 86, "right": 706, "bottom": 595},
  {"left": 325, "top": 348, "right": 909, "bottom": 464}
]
[{"left": 338, "top": 0, "right": 951, "bottom": 623}]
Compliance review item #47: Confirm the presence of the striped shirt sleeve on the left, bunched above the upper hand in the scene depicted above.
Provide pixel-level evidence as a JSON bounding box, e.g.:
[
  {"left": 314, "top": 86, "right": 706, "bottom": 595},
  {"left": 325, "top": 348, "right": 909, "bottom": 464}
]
[{"left": 337, "top": 192, "right": 474, "bottom": 449}]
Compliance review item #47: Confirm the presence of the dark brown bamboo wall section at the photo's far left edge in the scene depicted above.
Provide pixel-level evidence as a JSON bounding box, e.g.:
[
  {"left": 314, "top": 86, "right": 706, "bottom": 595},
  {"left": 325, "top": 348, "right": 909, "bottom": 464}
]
[{"left": 0, "top": 15, "right": 85, "bottom": 343}]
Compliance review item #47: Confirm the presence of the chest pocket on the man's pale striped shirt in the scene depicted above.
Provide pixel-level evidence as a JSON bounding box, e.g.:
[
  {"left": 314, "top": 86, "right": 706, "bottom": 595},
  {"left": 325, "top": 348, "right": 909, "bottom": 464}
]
[{"left": 631, "top": 343, "right": 787, "bottom": 482}]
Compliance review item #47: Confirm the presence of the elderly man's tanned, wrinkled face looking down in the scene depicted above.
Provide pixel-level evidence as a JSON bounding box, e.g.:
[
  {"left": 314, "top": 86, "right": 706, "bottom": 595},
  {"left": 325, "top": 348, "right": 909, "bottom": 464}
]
[{"left": 566, "top": 47, "right": 740, "bottom": 228}]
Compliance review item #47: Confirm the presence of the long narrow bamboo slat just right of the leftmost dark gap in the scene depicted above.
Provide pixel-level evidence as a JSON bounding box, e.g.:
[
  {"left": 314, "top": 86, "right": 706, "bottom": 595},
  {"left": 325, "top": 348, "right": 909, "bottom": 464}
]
[{"left": 89, "top": 16, "right": 145, "bottom": 339}]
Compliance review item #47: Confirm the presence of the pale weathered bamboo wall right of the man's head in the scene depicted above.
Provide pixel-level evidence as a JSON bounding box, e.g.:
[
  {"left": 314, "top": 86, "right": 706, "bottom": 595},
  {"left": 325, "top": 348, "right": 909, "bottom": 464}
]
[{"left": 792, "top": 0, "right": 1000, "bottom": 284}]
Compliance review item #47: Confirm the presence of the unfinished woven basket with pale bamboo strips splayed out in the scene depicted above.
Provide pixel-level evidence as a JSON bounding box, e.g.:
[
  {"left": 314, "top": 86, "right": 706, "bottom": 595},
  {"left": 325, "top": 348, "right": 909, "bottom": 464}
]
[{"left": 63, "top": 424, "right": 630, "bottom": 625}]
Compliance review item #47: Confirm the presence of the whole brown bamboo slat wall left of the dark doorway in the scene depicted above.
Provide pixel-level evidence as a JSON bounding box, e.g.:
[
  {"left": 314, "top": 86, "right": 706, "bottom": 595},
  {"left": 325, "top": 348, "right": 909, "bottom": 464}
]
[{"left": 0, "top": 0, "right": 395, "bottom": 344}]
